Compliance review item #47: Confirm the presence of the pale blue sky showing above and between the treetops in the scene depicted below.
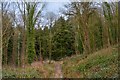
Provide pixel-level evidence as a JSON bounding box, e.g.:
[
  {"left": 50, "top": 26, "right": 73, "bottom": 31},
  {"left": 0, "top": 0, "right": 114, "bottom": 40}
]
[{"left": 3, "top": 2, "right": 67, "bottom": 26}]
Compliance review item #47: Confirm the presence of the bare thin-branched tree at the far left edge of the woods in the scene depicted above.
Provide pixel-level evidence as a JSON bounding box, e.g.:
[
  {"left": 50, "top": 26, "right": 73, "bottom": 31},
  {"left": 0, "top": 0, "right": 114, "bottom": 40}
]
[{"left": 1, "top": 2, "right": 12, "bottom": 65}]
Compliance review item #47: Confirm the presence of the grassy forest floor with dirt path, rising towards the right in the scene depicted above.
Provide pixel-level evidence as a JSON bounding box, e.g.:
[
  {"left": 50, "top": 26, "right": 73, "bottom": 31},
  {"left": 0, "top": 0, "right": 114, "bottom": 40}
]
[{"left": 2, "top": 47, "right": 118, "bottom": 78}]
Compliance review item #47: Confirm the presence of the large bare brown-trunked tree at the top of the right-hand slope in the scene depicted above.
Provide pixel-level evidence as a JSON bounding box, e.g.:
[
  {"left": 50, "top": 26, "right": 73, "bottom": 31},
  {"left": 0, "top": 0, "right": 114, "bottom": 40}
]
[{"left": 65, "top": 2, "right": 95, "bottom": 53}]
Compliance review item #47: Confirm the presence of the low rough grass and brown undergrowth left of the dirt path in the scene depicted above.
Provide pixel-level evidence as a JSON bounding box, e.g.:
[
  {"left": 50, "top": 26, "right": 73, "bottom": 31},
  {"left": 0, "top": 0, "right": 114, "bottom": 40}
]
[{"left": 2, "top": 64, "right": 54, "bottom": 78}]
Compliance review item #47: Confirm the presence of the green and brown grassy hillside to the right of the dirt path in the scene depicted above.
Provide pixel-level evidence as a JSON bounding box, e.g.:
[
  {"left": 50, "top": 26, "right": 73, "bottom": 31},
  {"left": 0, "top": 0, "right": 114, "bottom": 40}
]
[{"left": 63, "top": 47, "right": 118, "bottom": 78}]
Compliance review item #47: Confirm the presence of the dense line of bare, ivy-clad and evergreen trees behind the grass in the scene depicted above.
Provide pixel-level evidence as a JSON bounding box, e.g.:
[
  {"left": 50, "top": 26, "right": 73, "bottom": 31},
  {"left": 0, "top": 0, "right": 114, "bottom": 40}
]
[{"left": 2, "top": 2, "right": 119, "bottom": 66}]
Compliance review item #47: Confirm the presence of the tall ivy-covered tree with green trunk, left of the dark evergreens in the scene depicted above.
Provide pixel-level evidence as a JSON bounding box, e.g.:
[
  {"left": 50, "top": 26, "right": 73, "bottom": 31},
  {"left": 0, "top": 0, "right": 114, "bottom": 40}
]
[{"left": 26, "top": 2, "right": 44, "bottom": 63}]
